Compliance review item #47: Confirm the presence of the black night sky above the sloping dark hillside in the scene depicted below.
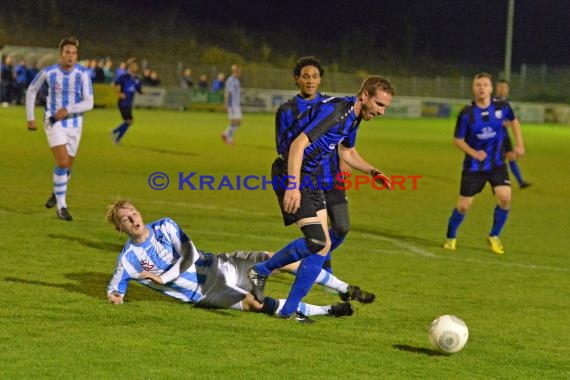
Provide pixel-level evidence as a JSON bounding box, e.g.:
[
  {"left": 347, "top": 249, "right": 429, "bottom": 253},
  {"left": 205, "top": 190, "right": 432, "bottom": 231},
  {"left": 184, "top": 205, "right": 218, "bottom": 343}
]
[{"left": 130, "top": 0, "right": 570, "bottom": 65}]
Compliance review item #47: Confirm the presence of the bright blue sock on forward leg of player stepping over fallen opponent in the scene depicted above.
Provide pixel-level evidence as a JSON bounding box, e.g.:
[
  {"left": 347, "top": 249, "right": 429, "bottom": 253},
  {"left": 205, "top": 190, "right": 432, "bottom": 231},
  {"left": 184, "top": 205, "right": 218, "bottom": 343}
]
[{"left": 279, "top": 253, "right": 325, "bottom": 317}]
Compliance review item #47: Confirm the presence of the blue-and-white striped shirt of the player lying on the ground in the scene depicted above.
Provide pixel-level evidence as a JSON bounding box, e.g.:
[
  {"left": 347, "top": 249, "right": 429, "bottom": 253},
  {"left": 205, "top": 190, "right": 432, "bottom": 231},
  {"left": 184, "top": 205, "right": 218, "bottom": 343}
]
[{"left": 107, "top": 218, "right": 213, "bottom": 303}]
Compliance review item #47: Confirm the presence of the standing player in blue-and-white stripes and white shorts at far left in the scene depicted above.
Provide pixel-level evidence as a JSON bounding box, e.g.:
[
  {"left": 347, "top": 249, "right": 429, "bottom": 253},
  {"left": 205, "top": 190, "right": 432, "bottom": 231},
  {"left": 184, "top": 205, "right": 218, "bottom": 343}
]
[{"left": 26, "top": 37, "right": 93, "bottom": 221}]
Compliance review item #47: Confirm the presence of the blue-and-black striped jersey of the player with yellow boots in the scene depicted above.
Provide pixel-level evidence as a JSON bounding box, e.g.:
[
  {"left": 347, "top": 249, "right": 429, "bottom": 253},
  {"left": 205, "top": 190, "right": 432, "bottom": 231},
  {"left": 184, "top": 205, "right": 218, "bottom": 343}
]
[{"left": 454, "top": 100, "right": 515, "bottom": 172}]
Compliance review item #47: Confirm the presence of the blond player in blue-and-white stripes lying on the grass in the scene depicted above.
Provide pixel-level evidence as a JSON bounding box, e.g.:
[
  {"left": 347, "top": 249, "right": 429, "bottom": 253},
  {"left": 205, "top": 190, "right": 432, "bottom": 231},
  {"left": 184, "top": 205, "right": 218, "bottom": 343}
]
[{"left": 107, "top": 200, "right": 375, "bottom": 317}]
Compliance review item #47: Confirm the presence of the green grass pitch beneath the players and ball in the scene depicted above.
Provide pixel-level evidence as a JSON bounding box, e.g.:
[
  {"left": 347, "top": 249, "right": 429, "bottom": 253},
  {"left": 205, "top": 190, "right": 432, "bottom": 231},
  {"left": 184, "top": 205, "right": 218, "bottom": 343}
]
[{"left": 0, "top": 107, "right": 570, "bottom": 379}]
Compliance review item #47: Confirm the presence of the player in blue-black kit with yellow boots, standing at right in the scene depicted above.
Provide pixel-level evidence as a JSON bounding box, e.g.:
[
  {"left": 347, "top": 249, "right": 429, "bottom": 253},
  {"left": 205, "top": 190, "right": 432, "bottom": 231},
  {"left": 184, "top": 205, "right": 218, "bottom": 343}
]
[{"left": 444, "top": 73, "right": 524, "bottom": 255}]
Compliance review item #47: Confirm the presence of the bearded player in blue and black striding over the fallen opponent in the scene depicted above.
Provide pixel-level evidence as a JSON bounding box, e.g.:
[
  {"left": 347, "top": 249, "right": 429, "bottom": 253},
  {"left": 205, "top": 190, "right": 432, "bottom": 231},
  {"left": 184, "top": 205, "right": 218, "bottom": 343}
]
[{"left": 248, "top": 76, "right": 395, "bottom": 320}]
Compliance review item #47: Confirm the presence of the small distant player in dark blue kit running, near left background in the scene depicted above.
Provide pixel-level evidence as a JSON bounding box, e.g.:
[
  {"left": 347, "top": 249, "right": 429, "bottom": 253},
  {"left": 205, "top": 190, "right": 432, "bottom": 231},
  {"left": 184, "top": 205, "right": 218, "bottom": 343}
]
[{"left": 111, "top": 58, "right": 142, "bottom": 144}]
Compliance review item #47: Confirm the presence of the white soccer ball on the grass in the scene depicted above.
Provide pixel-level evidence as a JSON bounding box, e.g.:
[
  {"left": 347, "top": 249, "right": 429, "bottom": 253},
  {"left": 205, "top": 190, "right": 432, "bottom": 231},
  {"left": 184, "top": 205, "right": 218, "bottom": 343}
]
[{"left": 428, "top": 315, "right": 469, "bottom": 354}]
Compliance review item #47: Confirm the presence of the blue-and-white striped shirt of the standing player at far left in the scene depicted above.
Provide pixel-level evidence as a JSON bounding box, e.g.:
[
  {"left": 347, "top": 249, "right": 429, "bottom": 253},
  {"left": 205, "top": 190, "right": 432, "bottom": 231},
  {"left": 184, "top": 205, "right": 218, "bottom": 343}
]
[{"left": 26, "top": 64, "right": 93, "bottom": 128}]
